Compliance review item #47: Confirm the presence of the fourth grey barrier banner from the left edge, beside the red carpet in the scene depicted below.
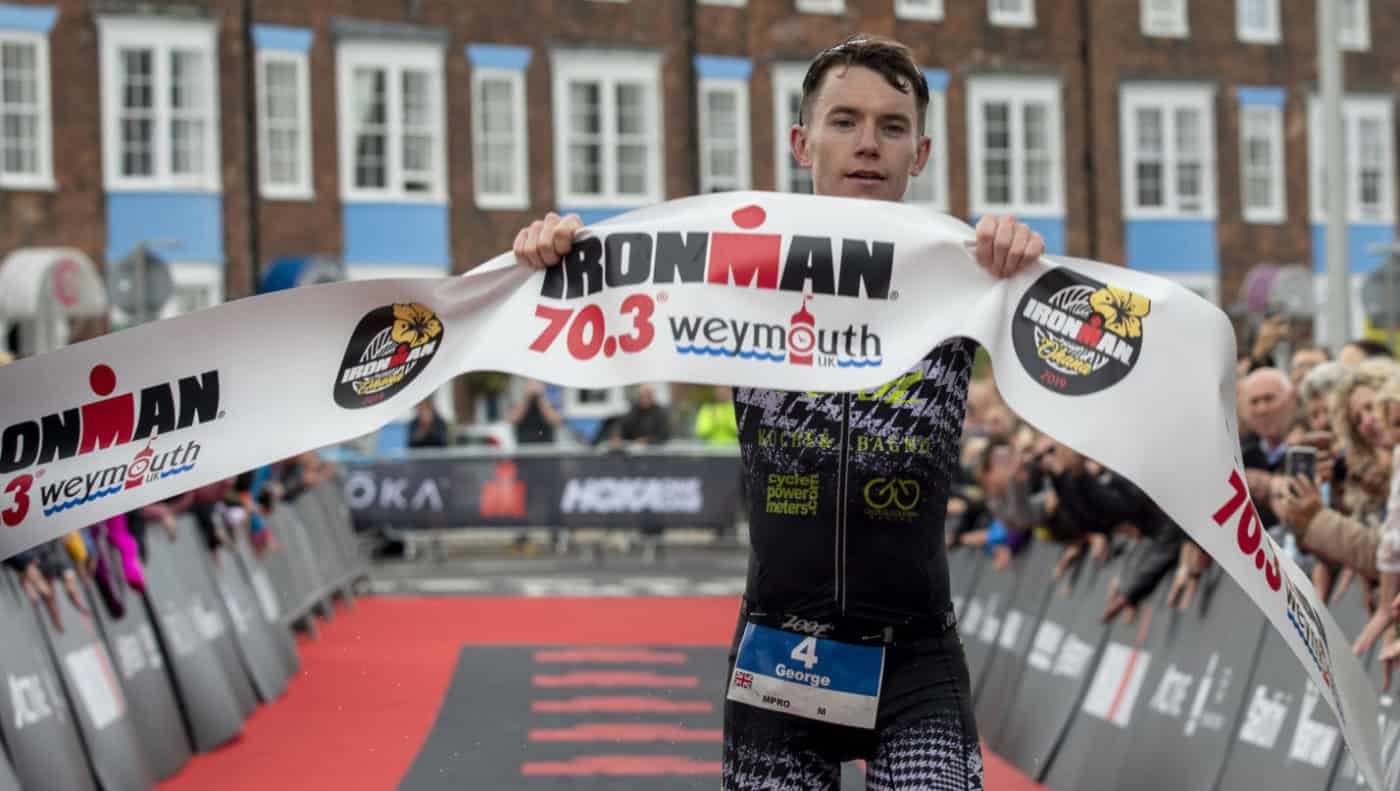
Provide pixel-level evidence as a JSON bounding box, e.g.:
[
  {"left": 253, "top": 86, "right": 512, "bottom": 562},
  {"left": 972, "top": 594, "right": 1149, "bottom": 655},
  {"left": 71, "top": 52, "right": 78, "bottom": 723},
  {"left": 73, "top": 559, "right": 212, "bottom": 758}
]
[{"left": 146, "top": 528, "right": 244, "bottom": 753}]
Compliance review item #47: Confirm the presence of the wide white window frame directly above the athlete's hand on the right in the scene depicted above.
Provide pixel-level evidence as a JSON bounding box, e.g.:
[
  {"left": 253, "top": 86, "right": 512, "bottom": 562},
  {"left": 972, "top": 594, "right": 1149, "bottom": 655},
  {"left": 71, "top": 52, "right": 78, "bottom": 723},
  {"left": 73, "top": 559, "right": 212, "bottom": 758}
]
[{"left": 967, "top": 76, "right": 1065, "bottom": 217}]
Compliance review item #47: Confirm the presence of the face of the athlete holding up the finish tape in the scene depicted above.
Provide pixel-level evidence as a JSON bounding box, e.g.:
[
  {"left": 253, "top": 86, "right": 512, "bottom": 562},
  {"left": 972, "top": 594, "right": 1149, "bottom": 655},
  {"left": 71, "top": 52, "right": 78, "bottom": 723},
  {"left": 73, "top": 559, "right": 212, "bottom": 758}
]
[{"left": 791, "top": 66, "right": 930, "bottom": 200}]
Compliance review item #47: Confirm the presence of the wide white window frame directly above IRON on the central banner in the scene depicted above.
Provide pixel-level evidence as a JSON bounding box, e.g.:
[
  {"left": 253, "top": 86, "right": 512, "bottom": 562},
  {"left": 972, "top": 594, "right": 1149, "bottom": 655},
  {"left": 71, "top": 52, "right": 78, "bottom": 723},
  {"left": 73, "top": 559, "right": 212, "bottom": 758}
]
[{"left": 552, "top": 50, "right": 666, "bottom": 209}]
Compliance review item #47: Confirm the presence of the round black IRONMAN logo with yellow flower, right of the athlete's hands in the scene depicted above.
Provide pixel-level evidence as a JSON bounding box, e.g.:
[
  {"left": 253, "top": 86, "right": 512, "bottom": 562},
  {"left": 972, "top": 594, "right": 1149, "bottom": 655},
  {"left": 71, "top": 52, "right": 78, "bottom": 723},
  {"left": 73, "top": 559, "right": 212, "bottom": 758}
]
[{"left": 1011, "top": 267, "right": 1152, "bottom": 395}]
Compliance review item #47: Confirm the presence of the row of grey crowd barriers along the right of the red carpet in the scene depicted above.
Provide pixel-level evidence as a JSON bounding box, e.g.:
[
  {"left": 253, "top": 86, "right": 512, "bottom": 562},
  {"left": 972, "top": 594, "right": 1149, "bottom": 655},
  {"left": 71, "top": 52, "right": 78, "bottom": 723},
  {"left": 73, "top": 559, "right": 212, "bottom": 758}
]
[{"left": 949, "top": 545, "right": 1400, "bottom": 791}]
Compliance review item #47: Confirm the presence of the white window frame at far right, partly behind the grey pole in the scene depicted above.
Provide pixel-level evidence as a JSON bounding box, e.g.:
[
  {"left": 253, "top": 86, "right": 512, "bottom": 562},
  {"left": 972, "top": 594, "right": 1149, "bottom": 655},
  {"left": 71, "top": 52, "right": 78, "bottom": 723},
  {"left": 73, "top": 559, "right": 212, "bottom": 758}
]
[{"left": 1308, "top": 95, "right": 1396, "bottom": 224}]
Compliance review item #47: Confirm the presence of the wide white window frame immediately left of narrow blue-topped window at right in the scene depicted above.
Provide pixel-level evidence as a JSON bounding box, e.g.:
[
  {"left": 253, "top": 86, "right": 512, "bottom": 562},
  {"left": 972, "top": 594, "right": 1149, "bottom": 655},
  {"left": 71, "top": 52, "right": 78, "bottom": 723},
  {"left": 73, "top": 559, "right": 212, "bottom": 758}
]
[{"left": 1119, "top": 83, "right": 1218, "bottom": 220}]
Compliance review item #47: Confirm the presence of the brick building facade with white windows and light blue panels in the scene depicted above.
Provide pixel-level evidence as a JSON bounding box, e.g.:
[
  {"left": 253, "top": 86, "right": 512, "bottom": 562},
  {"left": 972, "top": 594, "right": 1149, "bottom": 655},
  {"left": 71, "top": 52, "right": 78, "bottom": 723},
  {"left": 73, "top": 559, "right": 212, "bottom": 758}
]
[{"left": 0, "top": 0, "right": 1400, "bottom": 400}]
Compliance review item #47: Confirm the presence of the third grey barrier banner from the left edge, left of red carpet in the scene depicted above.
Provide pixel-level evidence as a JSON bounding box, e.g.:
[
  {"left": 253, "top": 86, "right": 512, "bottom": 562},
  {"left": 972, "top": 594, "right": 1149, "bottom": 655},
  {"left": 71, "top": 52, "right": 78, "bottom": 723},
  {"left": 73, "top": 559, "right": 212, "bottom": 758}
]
[{"left": 88, "top": 542, "right": 190, "bottom": 780}]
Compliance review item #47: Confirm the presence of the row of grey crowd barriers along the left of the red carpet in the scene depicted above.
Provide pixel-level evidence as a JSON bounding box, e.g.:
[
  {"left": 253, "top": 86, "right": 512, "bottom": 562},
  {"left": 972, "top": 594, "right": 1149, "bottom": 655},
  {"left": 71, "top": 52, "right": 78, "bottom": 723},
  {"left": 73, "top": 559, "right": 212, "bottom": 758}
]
[{"left": 0, "top": 482, "right": 368, "bottom": 791}]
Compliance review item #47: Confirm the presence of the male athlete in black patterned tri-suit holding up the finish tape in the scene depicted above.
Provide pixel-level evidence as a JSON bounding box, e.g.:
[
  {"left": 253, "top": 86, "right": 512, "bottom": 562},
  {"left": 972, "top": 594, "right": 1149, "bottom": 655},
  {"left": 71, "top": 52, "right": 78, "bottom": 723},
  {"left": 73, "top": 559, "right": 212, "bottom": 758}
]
[{"left": 514, "top": 36, "right": 1044, "bottom": 791}]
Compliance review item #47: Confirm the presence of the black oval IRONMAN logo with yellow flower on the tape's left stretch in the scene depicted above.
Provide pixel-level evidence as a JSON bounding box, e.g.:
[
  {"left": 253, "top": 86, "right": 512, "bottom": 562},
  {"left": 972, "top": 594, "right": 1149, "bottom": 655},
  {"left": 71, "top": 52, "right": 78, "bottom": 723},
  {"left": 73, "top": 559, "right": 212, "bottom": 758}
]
[{"left": 335, "top": 302, "right": 442, "bottom": 409}]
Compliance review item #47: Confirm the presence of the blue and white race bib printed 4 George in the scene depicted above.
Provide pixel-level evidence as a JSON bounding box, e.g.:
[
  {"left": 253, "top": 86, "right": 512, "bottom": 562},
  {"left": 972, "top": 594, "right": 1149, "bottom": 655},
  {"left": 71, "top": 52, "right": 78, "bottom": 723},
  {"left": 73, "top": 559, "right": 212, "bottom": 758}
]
[{"left": 728, "top": 623, "right": 885, "bottom": 728}]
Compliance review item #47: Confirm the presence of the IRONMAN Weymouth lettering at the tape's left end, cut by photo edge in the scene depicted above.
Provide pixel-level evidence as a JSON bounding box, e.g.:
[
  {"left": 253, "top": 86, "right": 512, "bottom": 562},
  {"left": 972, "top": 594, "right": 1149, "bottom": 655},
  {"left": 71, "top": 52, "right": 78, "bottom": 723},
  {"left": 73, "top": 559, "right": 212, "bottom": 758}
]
[{"left": 0, "top": 364, "right": 223, "bottom": 528}]
